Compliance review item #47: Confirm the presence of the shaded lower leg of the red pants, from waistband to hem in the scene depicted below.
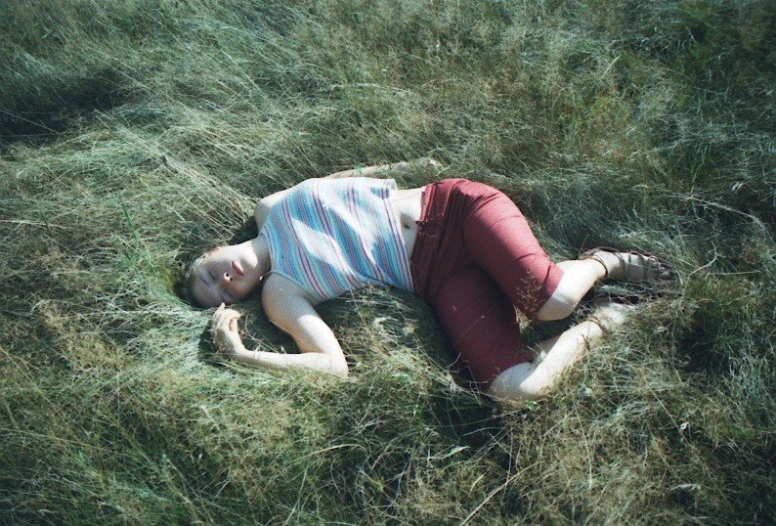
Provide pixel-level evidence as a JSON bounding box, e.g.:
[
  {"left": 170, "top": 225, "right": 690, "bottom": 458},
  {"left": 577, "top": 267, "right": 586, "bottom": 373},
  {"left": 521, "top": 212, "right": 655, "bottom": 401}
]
[{"left": 412, "top": 179, "right": 549, "bottom": 389}]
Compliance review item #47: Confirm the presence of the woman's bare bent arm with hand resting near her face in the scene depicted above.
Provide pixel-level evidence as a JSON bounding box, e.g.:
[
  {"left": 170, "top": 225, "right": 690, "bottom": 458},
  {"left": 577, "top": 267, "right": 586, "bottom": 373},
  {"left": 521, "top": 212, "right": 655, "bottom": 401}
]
[{"left": 213, "top": 275, "right": 348, "bottom": 377}]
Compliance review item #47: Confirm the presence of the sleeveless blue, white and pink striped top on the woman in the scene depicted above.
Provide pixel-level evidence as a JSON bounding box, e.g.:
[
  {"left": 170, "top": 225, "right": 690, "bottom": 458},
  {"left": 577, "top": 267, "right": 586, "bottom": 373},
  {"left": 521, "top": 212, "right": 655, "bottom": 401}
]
[{"left": 261, "top": 177, "right": 413, "bottom": 303}]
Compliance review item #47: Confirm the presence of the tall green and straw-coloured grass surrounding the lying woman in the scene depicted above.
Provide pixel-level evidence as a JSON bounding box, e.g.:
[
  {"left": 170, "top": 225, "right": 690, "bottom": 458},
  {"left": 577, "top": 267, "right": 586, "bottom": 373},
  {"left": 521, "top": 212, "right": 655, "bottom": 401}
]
[{"left": 0, "top": 0, "right": 776, "bottom": 525}]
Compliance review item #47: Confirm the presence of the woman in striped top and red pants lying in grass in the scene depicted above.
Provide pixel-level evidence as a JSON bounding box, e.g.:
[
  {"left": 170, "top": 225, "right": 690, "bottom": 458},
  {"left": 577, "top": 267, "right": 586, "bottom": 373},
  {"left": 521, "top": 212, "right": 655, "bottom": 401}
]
[{"left": 180, "top": 160, "right": 669, "bottom": 400}]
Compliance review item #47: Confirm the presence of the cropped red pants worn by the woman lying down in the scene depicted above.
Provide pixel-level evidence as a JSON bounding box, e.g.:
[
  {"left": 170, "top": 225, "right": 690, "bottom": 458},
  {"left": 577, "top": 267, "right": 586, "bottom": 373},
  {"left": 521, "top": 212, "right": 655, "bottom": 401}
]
[{"left": 411, "top": 179, "right": 563, "bottom": 390}]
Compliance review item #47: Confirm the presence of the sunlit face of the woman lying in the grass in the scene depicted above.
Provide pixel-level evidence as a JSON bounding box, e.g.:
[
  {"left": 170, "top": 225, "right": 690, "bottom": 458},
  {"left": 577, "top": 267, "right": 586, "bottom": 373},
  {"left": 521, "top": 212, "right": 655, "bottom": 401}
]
[{"left": 191, "top": 242, "right": 263, "bottom": 307}]
